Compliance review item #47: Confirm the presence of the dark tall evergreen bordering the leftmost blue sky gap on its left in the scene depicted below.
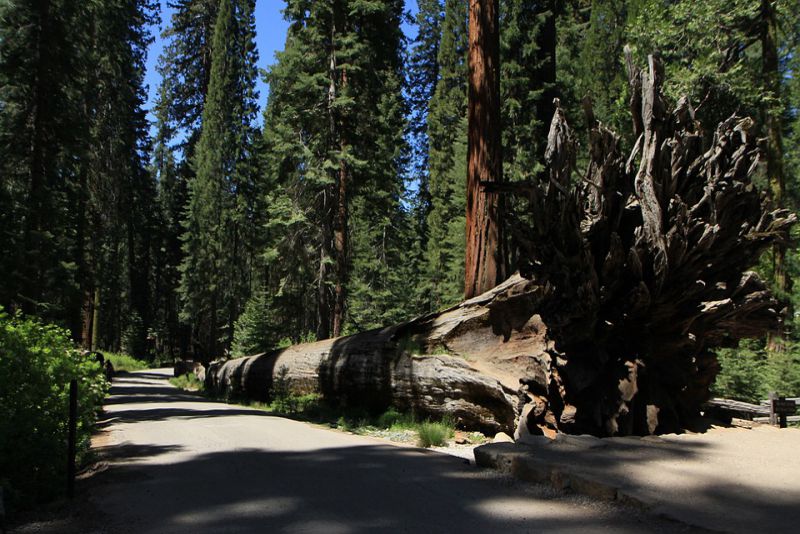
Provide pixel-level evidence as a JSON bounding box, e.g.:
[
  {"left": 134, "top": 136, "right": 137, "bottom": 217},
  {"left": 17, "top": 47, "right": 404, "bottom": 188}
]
[{"left": 83, "top": 0, "right": 156, "bottom": 356}]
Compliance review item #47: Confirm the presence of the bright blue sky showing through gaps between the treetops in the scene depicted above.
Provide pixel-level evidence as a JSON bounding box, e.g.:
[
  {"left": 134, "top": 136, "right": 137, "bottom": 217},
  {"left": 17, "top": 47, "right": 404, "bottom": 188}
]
[{"left": 145, "top": 0, "right": 417, "bottom": 130}]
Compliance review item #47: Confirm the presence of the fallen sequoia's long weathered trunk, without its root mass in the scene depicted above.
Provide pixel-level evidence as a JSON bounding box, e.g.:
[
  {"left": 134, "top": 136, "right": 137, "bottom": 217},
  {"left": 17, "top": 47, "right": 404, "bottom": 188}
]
[{"left": 206, "top": 276, "right": 547, "bottom": 433}]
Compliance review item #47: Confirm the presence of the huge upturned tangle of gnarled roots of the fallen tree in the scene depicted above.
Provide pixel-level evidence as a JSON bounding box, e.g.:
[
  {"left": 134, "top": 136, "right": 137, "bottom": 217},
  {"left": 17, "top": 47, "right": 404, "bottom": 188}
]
[{"left": 487, "top": 51, "right": 795, "bottom": 436}]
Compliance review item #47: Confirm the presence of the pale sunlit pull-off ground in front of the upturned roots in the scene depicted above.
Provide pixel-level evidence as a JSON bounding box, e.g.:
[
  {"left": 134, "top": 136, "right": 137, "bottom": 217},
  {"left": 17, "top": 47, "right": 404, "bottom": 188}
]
[{"left": 475, "top": 426, "right": 800, "bottom": 534}]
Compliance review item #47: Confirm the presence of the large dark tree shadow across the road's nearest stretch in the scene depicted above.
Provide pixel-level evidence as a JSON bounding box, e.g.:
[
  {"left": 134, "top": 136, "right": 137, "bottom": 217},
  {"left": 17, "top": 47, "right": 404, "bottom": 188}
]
[{"left": 84, "top": 445, "right": 692, "bottom": 533}]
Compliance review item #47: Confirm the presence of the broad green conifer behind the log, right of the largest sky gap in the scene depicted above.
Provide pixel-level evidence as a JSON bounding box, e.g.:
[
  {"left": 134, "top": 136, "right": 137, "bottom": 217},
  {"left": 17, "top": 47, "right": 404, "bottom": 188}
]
[{"left": 265, "top": 1, "right": 411, "bottom": 338}]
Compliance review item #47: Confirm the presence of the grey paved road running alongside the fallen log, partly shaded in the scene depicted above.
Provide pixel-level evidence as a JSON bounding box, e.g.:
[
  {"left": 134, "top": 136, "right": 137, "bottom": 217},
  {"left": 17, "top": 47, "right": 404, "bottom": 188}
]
[{"left": 84, "top": 370, "right": 687, "bottom": 534}]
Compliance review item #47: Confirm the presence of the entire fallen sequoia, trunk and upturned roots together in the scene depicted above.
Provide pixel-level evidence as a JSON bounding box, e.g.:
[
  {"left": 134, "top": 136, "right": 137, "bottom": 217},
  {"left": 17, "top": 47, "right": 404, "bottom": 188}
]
[{"left": 206, "top": 57, "right": 795, "bottom": 437}]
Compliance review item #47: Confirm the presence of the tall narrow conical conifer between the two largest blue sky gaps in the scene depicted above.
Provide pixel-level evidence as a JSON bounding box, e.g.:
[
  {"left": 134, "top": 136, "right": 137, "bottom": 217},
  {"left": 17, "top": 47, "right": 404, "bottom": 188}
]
[{"left": 180, "top": 0, "right": 257, "bottom": 357}]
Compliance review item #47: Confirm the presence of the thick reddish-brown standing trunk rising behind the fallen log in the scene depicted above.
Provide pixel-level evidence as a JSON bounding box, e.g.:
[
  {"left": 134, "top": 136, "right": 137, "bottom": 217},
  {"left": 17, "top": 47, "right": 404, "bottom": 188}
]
[{"left": 464, "top": 0, "right": 505, "bottom": 298}]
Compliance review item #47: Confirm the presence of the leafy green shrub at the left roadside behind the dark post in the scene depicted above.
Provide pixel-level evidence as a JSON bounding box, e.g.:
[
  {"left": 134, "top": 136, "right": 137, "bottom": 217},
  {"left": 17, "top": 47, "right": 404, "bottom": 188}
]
[{"left": 0, "top": 310, "right": 107, "bottom": 510}]
